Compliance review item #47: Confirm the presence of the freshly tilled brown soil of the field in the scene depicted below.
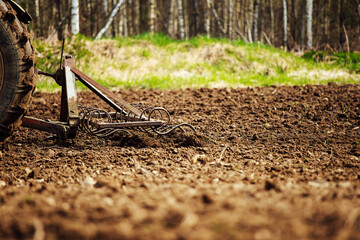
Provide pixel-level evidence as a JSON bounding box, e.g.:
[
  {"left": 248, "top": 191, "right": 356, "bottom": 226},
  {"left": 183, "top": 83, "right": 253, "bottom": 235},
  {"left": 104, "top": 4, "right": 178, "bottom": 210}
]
[{"left": 0, "top": 85, "right": 360, "bottom": 239}]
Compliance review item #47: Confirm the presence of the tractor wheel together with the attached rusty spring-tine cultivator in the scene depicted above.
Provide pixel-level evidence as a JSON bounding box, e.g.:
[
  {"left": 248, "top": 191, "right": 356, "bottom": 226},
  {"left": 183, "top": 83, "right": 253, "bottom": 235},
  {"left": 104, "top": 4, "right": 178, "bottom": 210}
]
[{"left": 0, "top": 0, "right": 195, "bottom": 140}]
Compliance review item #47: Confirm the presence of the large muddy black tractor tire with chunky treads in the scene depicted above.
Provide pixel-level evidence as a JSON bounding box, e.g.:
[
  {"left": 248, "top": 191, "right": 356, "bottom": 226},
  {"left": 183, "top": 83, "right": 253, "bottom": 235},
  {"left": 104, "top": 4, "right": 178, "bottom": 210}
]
[{"left": 0, "top": 0, "right": 37, "bottom": 141}]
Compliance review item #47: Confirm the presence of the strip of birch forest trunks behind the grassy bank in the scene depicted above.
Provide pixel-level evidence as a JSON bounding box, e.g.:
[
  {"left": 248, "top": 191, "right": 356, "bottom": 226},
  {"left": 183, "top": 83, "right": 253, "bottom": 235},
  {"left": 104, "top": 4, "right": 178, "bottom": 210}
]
[{"left": 17, "top": 0, "right": 360, "bottom": 52}]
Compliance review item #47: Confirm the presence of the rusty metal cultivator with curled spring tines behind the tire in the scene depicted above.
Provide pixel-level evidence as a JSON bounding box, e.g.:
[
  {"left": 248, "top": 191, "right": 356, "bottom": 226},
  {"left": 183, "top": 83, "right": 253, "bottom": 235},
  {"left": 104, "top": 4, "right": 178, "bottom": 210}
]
[{"left": 22, "top": 46, "right": 195, "bottom": 139}]
